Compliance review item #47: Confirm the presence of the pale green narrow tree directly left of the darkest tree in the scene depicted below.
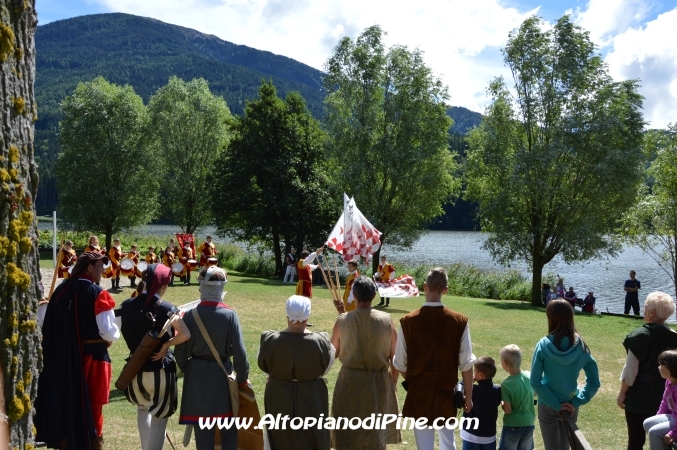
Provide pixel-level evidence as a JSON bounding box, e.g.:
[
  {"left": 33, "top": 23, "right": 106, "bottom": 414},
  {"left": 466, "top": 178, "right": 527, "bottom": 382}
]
[{"left": 148, "top": 77, "right": 231, "bottom": 233}]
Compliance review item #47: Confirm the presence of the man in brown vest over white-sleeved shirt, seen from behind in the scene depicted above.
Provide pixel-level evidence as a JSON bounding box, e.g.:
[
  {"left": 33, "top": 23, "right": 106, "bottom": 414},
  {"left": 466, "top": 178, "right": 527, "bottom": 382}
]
[{"left": 393, "top": 267, "right": 475, "bottom": 450}]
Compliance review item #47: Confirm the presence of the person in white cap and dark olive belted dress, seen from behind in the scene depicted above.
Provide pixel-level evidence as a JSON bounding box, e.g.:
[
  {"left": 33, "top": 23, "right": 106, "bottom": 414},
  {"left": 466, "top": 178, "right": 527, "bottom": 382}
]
[{"left": 258, "top": 295, "right": 335, "bottom": 450}]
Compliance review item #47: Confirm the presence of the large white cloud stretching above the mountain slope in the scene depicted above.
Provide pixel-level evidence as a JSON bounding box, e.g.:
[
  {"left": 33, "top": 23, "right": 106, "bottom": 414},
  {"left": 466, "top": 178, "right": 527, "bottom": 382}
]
[{"left": 92, "top": 0, "right": 538, "bottom": 111}]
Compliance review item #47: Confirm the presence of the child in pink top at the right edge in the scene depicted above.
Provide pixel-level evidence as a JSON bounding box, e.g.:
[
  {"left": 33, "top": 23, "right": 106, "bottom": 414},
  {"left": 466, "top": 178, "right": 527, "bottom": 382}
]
[{"left": 644, "top": 350, "right": 677, "bottom": 450}]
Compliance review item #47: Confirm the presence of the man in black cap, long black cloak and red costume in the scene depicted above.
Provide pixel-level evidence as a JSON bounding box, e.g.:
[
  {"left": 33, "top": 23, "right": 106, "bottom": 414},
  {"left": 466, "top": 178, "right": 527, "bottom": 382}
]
[{"left": 35, "top": 252, "right": 120, "bottom": 450}]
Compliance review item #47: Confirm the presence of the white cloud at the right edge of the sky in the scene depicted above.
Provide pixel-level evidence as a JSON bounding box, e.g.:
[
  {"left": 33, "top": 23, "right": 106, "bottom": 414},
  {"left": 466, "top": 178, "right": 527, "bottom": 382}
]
[{"left": 606, "top": 8, "right": 677, "bottom": 128}]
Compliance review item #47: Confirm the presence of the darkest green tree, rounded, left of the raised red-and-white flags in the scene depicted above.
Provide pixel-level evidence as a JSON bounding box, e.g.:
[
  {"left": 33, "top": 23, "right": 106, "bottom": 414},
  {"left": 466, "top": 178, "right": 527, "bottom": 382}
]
[{"left": 211, "top": 82, "right": 340, "bottom": 274}]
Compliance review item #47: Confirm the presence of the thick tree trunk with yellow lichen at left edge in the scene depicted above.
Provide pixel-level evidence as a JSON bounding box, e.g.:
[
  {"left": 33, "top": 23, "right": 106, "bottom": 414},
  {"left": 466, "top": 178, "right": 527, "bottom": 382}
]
[{"left": 0, "top": 0, "right": 42, "bottom": 448}]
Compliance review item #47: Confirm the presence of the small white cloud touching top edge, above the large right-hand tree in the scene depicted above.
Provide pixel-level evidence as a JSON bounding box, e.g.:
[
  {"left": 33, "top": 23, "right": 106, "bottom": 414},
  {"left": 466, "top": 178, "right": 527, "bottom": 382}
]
[{"left": 567, "top": 0, "right": 657, "bottom": 47}]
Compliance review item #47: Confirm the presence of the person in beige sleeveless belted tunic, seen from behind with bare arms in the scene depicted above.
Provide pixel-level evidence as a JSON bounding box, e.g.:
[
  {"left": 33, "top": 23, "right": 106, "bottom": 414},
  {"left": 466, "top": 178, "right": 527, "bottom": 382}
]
[{"left": 328, "top": 277, "right": 402, "bottom": 450}]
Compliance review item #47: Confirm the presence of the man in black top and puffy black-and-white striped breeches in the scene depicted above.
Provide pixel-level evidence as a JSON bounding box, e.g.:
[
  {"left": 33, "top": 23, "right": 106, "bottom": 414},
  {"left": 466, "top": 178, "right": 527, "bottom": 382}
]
[{"left": 120, "top": 264, "right": 190, "bottom": 450}]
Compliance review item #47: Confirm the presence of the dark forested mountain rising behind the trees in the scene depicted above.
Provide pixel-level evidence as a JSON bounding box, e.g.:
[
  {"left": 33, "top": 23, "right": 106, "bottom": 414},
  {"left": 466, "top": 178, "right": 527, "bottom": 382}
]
[{"left": 35, "top": 13, "right": 482, "bottom": 229}]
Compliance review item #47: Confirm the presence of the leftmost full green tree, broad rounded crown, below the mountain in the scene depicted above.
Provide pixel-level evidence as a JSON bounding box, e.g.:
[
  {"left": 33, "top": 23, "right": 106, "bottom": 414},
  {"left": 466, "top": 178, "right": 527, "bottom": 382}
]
[{"left": 56, "top": 77, "right": 158, "bottom": 248}]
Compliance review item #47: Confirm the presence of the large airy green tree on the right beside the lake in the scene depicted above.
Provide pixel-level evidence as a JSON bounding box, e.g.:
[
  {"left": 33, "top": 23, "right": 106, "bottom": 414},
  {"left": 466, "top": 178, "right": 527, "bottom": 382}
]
[{"left": 466, "top": 16, "right": 644, "bottom": 305}]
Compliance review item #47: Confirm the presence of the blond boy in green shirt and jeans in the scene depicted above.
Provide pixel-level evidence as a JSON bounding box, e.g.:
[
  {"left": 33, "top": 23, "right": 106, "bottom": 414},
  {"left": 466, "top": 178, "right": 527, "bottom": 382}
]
[{"left": 498, "top": 344, "right": 536, "bottom": 450}]
